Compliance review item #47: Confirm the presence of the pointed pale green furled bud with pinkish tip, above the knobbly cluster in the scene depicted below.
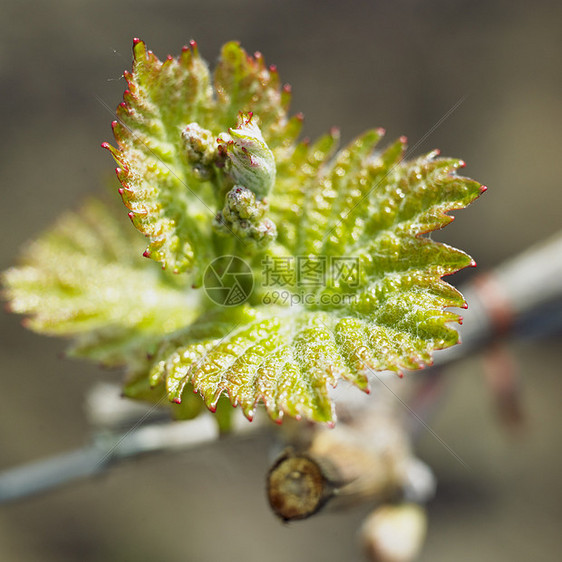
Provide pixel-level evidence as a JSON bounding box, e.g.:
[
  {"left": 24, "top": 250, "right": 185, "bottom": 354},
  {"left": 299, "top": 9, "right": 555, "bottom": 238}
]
[{"left": 218, "top": 113, "right": 276, "bottom": 199}]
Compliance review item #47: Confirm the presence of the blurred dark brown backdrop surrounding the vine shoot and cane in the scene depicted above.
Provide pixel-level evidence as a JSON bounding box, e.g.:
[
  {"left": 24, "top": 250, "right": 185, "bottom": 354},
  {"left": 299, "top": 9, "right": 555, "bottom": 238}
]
[{"left": 0, "top": 0, "right": 562, "bottom": 562}]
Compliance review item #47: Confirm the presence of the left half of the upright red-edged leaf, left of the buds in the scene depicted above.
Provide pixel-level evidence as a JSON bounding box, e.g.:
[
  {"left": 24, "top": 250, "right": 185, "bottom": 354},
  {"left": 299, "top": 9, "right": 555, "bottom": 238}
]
[{"left": 104, "top": 41, "right": 214, "bottom": 272}]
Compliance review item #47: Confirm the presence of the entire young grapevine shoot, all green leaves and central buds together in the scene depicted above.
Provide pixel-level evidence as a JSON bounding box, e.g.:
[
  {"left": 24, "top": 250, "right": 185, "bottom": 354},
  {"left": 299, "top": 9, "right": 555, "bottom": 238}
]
[{"left": 4, "top": 40, "right": 483, "bottom": 427}]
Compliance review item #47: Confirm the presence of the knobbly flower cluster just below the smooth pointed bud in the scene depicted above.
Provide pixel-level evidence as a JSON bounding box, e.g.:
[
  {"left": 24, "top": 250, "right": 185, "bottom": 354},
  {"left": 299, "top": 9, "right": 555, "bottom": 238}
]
[{"left": 213, "top": 185, "right": 277, "bottom": 248}]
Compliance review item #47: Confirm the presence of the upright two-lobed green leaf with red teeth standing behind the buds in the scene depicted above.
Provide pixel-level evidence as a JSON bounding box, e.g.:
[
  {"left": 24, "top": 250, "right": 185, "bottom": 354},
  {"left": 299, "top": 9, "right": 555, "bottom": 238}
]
[{"left": 103, "top": 40, "right": 301, "bottom": 274}]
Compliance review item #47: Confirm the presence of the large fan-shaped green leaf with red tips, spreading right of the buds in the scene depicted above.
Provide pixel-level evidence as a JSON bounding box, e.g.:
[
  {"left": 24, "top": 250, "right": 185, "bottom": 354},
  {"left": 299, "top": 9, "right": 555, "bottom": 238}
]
[{"left": 151, "top": 131, "right": 481, "bottom": 422}]
